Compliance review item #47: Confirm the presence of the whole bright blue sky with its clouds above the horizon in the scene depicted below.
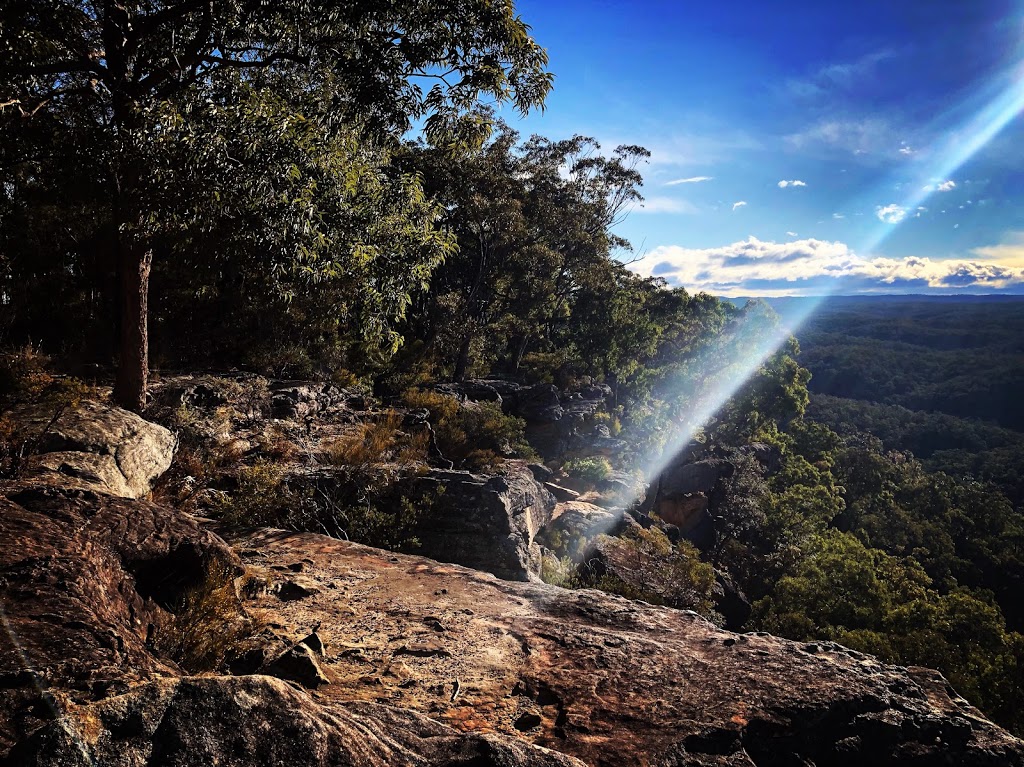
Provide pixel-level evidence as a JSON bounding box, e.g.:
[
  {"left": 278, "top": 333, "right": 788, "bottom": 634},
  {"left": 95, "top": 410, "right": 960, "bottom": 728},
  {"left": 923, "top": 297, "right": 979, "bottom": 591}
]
[{"left": 503, "top": 0, "right": 1024, "bottom": 296}]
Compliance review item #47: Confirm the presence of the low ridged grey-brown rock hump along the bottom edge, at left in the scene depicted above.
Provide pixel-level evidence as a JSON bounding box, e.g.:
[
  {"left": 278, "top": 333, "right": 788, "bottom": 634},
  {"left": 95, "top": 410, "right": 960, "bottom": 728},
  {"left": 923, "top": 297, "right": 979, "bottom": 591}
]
[{"left": 3, "top": 676, "right": 583, "bottom": 767}]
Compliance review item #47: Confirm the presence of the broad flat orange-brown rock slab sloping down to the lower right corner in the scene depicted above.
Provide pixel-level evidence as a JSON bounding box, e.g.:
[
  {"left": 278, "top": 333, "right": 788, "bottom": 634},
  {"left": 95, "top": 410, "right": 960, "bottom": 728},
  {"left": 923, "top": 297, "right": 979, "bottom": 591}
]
[{"left": 228, "top": 530, "right": 1024, "bottom": 767}]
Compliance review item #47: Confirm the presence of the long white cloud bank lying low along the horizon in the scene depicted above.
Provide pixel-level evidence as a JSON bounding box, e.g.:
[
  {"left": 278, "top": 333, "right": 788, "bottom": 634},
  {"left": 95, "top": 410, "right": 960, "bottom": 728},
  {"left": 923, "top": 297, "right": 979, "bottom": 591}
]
[{"left": 630, "top": 237, "right": 1024, "bottom": 296}]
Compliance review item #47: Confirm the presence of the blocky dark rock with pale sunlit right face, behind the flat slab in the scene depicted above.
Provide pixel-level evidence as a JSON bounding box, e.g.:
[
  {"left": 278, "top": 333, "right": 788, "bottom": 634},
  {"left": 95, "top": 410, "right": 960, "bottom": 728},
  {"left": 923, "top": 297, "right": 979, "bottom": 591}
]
[{"left": 415, "top": 462, "right": 555, "bottom": 581}]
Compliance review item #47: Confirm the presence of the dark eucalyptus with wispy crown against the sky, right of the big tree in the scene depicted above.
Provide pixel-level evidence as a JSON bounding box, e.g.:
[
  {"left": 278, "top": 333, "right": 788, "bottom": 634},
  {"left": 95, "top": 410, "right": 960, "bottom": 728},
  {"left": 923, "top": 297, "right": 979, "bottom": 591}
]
[{"left": 416, "top": 125, "right": 647, "bottom": 380}]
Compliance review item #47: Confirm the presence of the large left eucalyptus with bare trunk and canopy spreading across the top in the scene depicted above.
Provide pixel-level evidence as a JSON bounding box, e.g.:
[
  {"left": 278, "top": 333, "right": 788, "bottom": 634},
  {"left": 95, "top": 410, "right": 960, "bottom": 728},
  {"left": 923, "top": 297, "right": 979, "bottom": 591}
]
[{"left": 0, "top": 0, "right": 551, "bottom": 410}]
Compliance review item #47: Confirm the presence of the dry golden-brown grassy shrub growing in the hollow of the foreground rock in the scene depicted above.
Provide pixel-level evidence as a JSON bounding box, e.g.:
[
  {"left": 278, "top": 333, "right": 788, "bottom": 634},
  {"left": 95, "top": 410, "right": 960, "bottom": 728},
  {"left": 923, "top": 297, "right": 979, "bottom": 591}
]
[{"left": 153, "top": 562, "right": 263, "bottom": 674}]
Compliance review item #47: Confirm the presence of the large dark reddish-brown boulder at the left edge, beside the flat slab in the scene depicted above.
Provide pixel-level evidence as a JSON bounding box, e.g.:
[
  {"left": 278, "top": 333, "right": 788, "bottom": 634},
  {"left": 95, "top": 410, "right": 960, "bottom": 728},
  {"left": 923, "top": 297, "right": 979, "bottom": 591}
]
[{"left": 0, "top": 485, "right": 239, "bottom": 753}]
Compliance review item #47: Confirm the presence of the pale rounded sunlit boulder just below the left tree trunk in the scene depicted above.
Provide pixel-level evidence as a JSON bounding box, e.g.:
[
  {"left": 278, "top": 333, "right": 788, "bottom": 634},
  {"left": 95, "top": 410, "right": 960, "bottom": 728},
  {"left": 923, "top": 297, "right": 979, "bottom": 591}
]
[{"left": 14, "top": 401, "right": 175, "bottom": 498}]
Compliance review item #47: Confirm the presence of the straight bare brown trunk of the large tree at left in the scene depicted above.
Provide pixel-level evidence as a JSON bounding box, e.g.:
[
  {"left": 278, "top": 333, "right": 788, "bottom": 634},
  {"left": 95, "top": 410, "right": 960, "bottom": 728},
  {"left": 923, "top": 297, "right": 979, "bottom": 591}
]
[{"left": 114, "top": 237, "right": 153, "bottom": 413}]
